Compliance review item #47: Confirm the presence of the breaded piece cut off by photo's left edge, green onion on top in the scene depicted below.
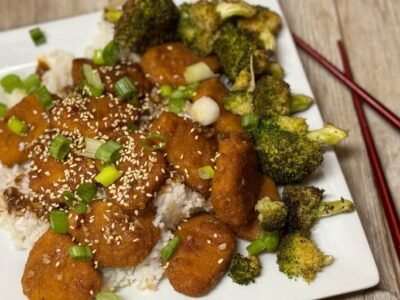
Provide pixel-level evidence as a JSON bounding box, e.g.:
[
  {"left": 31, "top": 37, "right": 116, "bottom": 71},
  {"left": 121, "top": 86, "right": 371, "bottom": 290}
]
[{"left": 0, "top": 96, "right": 49, "bottom": 167}]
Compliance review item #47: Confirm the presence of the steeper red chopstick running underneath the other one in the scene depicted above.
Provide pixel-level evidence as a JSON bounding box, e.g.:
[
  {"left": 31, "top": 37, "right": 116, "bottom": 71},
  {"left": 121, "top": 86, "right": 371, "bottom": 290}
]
[{"left": 338, "top": 41, "right": 400, "bottom": 260}]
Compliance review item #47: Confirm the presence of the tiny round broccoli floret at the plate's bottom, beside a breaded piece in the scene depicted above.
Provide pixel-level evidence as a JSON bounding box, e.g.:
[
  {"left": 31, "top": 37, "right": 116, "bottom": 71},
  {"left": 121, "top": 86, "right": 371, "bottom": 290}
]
[{"left": 228, "top": 253, "right": 261, "bottom": 285}]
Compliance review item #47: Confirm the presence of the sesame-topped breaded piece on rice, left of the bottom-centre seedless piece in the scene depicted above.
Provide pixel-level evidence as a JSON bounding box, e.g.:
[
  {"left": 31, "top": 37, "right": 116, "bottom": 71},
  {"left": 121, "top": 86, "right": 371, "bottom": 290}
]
[{"left": 68, "top": 201, "right": 160, "bottom": 268}]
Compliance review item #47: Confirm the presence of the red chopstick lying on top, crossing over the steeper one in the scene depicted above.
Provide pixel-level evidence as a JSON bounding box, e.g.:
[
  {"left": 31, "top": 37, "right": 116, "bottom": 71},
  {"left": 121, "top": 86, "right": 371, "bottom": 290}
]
[{"left": 293, "top": 34, "right": 400, "bottom": 130}]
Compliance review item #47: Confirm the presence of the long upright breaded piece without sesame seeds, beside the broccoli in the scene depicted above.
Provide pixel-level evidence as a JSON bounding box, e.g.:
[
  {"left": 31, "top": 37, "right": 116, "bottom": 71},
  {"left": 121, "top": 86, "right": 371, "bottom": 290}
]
[{"left": 211, "top": 134, "right": 261, "bottom": 226}]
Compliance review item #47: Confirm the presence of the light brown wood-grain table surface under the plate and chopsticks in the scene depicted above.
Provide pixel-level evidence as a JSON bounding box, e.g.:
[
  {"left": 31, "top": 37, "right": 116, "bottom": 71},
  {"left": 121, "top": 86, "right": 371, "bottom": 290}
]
[{"left": 0, "top": 0, "right": 400, "bottom": 299}]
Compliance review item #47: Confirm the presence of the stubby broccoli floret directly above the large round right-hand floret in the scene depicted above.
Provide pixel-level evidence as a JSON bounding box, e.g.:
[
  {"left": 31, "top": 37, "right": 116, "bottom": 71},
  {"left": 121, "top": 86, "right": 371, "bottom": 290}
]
[{"left": 254, "top": 75, "right": 290, "bottom": 117}]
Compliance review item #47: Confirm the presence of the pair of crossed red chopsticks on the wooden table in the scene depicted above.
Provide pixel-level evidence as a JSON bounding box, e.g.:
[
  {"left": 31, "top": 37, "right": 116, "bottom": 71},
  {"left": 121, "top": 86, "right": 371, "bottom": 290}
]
[{"left": 293, "top": 34, "right": 400, "bottom": 259}]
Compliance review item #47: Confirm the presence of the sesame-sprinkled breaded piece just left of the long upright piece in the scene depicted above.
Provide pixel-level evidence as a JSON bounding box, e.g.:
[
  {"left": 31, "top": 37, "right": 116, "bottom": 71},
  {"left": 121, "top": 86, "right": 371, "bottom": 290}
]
[{"left": 150, "top": 112, "right": 217, "bottom": 195}]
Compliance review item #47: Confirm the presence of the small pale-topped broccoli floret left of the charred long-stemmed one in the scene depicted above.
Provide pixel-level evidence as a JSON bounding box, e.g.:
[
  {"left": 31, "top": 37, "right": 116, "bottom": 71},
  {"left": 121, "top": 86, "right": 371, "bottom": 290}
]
[{"left": 256, "top": 197, "right": 287, "bottom": 231}]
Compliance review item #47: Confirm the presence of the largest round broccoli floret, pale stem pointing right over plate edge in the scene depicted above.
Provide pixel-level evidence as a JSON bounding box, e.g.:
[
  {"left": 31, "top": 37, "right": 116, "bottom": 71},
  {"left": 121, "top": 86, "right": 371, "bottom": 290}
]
[{"left": 253, "top": 116, "right": 347, "bottom": 184}]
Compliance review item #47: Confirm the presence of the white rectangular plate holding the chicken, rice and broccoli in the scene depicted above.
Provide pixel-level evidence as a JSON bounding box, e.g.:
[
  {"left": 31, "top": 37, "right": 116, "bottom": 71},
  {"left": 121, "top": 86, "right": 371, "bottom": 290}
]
[{"left": 0, "top": 0, "right": 379, "bottom": 300}]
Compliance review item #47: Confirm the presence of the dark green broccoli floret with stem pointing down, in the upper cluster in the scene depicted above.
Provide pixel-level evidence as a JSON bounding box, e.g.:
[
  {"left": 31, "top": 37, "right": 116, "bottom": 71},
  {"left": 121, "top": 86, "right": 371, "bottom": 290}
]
[{"left": 214, "top": 22, "right": 268, "bottom": 90}]
